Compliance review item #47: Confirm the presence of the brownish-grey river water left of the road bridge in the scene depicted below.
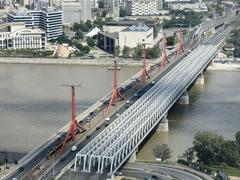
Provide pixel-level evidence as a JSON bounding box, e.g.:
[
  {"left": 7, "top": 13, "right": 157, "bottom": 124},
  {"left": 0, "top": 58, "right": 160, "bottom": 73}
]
[{"left": 0, "top": 64, "right": 140, "bottom": 153}]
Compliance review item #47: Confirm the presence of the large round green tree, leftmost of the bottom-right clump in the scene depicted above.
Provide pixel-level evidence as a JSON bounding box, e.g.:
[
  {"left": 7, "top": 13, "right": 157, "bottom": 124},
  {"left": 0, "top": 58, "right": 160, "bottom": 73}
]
[{"left": 193, "top": 131, "right": 224, "bottom": 164}]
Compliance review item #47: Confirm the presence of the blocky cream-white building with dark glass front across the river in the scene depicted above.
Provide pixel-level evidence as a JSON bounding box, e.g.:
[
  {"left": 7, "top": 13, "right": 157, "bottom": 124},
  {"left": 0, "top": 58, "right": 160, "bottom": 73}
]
[{"left": 98, "top": 20, "right": 162, "bottom": 53}]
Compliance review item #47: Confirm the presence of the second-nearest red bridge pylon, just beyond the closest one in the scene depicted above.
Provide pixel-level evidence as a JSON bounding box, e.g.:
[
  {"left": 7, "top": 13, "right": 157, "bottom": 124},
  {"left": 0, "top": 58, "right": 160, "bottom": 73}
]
[{"left": 106, "top": 60, "right": 123, "bottom": 113}]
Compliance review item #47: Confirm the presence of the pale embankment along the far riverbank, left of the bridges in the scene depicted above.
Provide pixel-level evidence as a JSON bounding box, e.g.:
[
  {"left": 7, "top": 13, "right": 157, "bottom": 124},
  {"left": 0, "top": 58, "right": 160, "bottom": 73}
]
[{"left": 0, "top": 57, "right": 149, "bottom": 66}]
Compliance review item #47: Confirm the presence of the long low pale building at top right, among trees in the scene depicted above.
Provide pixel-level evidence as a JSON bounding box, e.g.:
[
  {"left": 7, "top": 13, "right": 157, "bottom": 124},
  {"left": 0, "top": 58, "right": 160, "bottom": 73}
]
[{"left": 168, "top": 3, "right": 208, "bottom": 12}]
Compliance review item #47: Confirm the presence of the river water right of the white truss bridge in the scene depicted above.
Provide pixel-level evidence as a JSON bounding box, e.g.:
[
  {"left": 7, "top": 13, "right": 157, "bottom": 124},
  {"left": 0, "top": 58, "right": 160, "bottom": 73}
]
[{"left": 137, "top": 71, "right": 240, "bottom": 161}]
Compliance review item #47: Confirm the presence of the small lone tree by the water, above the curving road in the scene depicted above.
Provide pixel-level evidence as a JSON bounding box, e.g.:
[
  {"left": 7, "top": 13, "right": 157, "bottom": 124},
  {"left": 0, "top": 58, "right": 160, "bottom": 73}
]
[{"left": 152, "top": 144, "right": 171, "bottom": 161}]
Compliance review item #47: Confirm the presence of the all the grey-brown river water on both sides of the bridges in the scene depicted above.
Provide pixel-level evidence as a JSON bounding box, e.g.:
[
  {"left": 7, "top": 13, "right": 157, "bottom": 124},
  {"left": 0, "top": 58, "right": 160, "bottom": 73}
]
[{"left": 0, "top": 64, "right": 240, "bottom": 160}]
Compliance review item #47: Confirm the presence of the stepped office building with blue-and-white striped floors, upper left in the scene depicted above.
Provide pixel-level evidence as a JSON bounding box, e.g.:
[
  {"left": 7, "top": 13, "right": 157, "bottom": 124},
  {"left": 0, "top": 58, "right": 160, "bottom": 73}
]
[{"left": 7, "top": 7, "right": 63, "bottom": 40}]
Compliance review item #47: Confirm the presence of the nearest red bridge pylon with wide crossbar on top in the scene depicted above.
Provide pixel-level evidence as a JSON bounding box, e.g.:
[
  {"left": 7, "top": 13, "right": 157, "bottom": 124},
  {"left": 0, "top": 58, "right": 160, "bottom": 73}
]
[{"left": 61, "top": 84, "right": 86, "bottom": 154}]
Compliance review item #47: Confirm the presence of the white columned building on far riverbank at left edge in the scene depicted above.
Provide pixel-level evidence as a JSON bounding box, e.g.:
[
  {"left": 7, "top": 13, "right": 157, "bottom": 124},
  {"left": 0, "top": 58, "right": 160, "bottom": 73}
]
[{"left": 0, "top": 23, "right": 47, "bottom": 49}]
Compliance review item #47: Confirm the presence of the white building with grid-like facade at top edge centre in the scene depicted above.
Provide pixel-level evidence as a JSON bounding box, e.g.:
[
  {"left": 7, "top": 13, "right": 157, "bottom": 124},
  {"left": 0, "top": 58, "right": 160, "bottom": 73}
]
[{"left": 126, "top": 0, "right": 158, "bottom": 16}]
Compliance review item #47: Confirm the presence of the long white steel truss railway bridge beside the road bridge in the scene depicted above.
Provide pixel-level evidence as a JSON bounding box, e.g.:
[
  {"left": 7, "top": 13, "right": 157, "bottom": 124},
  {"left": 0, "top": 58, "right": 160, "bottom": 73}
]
[{"left": 74, "top": 45, "right": 217, "bottom": 174}]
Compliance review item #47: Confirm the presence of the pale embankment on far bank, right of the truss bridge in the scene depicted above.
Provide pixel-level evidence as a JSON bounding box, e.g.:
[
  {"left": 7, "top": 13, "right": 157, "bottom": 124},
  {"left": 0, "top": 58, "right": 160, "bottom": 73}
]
[{"left": 207, "top": 63, "right": 240, "bottom": 71}]
